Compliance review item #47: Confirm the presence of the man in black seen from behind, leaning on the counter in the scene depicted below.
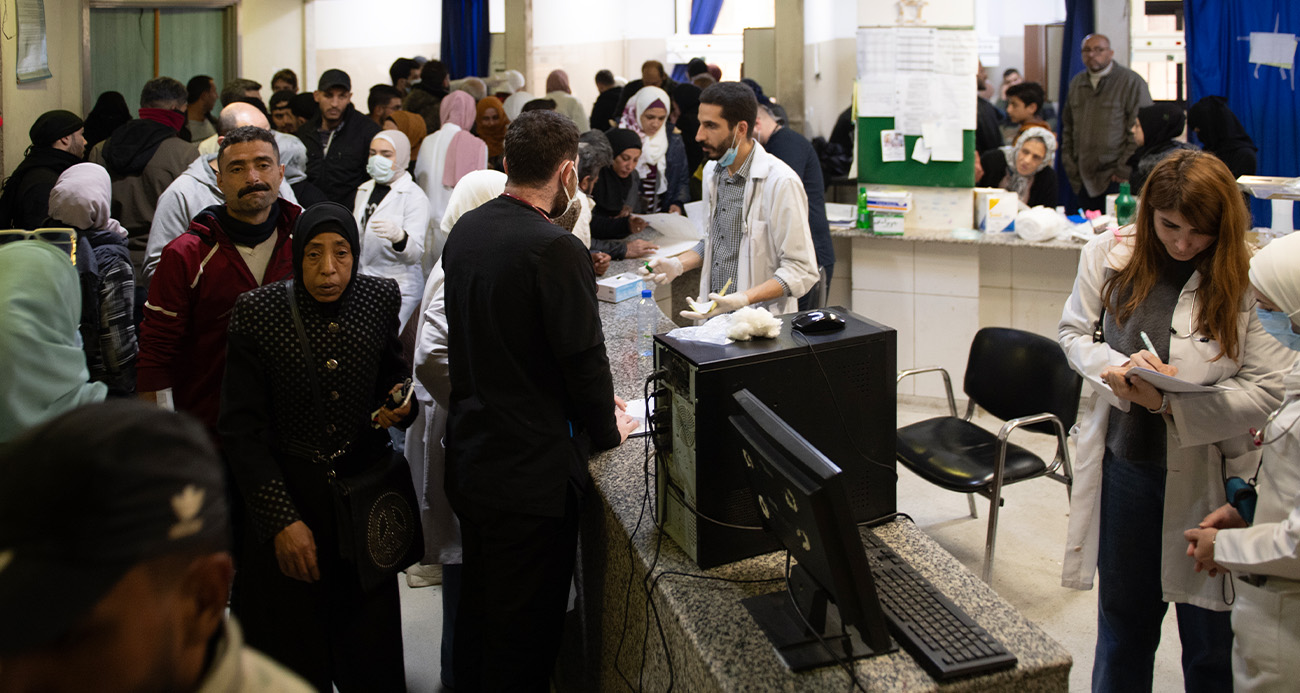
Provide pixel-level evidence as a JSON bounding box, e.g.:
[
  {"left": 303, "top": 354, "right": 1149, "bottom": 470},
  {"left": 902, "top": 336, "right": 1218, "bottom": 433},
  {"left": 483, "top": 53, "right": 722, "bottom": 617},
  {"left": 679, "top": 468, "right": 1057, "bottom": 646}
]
[{"left": 442, "top": 111, "right": 636, "bottom": 692}]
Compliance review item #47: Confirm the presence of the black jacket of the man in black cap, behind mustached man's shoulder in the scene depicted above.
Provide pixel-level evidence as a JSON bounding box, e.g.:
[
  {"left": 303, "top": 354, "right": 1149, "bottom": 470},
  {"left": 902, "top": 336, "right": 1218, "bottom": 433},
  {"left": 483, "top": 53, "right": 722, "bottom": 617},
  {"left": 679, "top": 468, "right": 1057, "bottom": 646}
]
[{"left": 296, "top": 104, "right": 380, "bottom": 209}]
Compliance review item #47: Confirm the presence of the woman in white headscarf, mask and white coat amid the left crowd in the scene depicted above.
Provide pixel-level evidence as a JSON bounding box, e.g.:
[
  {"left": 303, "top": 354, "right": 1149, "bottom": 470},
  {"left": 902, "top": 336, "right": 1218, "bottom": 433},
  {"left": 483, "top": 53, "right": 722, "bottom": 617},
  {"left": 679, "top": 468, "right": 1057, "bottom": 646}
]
[{"left": 352, "top": 130, "right": 428, "bottom": 325}]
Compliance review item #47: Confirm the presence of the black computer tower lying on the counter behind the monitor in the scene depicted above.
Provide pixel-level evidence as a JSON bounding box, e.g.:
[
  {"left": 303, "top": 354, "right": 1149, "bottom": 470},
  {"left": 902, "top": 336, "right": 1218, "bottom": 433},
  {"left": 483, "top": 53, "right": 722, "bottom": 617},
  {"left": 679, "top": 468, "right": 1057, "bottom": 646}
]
[{"left": 654, "top": 308, "right": 897, "bottom": 568}]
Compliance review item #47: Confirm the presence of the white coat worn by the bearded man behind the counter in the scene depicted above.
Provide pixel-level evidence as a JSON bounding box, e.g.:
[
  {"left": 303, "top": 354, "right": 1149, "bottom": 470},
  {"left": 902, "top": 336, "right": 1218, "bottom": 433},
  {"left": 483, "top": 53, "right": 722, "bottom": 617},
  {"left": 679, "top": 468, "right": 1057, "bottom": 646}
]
[{"left": 697, "top": 140, "right": 819, "bottom": 315}]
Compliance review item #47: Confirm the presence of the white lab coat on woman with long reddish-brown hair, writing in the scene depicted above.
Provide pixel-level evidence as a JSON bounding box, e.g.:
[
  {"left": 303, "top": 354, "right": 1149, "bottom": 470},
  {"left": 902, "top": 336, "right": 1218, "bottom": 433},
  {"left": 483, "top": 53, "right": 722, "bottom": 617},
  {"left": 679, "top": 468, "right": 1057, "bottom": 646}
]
[{"left": 1060, "top": 226, "right": 1294, "bottom": 611}]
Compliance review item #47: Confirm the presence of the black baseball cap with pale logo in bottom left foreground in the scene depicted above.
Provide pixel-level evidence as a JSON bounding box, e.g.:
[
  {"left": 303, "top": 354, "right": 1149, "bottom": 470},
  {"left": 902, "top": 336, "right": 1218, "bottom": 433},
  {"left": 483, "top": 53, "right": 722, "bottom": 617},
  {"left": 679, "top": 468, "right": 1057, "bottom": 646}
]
[{"left": 0, "top": 400, "right": 230, "bottom": 654}]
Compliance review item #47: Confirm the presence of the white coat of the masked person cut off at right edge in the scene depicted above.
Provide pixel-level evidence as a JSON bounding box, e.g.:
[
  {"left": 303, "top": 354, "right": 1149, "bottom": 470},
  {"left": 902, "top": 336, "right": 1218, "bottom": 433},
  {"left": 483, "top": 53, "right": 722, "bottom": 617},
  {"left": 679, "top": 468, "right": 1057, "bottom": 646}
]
[{"left": 1211, "top": 363, "right": 1300, "bottom": 693}]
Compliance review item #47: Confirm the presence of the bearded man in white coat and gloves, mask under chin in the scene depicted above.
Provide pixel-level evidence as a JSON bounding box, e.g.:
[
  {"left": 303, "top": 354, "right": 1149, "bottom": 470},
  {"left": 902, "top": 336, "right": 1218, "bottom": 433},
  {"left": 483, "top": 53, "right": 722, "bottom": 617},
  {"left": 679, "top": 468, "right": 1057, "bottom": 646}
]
[{"left": 639, "top": 82, "right": 818, "bottom": 320}]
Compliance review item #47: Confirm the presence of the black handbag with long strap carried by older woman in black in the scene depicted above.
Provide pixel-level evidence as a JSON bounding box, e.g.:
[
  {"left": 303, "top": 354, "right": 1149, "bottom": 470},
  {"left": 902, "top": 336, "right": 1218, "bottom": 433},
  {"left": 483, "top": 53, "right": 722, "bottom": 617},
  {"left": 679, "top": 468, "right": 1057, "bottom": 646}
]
[{"left": 289, "top": 280, "right": 424, "bottom": 590}]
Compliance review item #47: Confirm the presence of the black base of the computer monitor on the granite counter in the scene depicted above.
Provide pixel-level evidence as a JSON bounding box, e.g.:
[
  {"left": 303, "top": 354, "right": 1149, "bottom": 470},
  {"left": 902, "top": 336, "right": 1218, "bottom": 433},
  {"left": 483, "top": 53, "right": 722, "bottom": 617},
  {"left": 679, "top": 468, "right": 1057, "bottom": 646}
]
[{"left": 741, "top": 566, "right": 898, "bottom": 671}]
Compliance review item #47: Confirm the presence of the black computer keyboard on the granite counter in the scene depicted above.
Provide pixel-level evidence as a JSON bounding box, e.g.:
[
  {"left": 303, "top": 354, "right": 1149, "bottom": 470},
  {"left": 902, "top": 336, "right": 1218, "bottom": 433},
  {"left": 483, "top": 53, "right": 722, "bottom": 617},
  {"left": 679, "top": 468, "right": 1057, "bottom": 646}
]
[{"left": 863, "top": 530, "right": 1017, "bottom": 679}]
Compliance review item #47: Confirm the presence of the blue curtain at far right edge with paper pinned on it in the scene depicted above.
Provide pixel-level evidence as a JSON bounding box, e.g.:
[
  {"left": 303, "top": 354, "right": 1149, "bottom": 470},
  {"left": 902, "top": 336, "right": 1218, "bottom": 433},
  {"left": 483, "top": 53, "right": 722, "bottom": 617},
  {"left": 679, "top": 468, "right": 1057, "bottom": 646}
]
[{"left": 1183, "top": 0, "right": 1300, "bottom": 228}]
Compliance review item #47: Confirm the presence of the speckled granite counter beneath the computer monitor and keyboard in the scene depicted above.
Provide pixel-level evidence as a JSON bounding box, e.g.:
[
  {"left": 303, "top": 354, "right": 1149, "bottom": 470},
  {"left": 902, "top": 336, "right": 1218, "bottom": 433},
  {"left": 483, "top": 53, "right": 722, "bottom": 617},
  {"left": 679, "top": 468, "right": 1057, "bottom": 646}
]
[{"left": 560, "top": 273, "right": 1071, "bottom": 693}]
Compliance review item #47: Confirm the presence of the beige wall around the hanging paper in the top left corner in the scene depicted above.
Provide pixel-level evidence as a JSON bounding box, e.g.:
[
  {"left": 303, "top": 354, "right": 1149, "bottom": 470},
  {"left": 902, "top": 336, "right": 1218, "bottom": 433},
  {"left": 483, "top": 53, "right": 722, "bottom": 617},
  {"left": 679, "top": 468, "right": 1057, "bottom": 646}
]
[{"left": 0, "top": 0, "right": 85, "bottom": 176}]
